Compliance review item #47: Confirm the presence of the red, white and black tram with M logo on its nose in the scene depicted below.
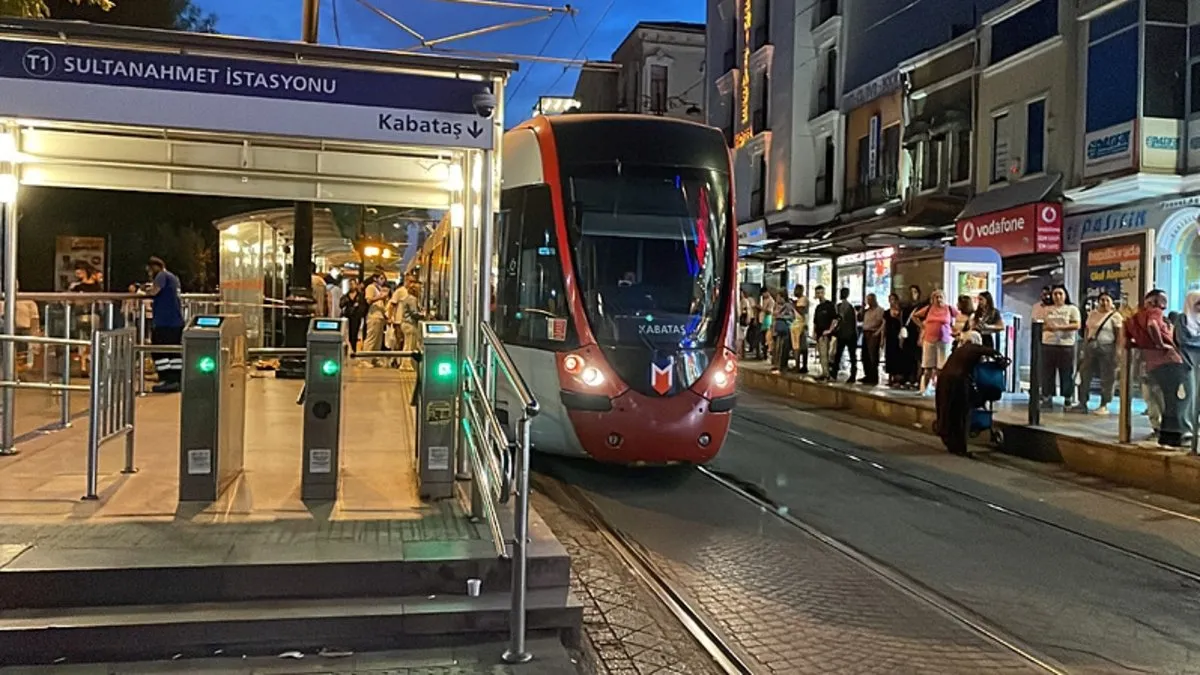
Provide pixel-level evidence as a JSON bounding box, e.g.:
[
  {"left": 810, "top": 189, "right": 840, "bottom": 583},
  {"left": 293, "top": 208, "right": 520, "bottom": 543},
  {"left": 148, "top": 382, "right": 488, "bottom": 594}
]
[{"left": 412, "top": 114, "right": 737, "bottom": 465}]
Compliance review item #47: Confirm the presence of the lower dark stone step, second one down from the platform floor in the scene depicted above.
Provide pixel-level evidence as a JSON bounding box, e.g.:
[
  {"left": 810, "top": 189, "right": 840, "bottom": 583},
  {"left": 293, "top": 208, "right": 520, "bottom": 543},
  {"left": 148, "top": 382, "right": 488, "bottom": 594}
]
[{"left": 0, "top": 587, "right": 583, "bottom": 665}]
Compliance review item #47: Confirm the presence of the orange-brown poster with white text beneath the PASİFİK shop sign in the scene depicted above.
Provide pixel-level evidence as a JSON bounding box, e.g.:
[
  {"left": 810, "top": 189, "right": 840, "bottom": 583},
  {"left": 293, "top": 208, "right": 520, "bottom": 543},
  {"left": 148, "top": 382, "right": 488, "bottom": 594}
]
[{"left": 1080, "top": 235, "right": 1146, "bottom": 316}]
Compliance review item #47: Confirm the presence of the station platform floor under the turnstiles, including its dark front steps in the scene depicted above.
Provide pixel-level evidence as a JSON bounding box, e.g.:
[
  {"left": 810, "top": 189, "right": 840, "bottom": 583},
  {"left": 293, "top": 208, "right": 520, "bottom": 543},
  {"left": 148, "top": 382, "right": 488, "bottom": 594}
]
[{"left": 0, "top": 369, "right": 581, "bottom": 663}]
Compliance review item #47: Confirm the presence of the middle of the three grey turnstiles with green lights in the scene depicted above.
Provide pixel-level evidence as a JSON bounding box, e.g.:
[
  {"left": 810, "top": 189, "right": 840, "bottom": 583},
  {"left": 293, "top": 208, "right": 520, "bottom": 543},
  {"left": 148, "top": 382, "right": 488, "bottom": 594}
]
[{"left": 300, "top": 318, "right": 347, "bottom": 501}]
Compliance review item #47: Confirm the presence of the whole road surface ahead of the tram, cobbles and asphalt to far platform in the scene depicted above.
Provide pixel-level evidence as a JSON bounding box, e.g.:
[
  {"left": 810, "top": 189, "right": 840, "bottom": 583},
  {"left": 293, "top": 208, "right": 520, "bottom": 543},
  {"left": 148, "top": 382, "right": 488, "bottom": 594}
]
[{"left": 540, "top": 395, "right": 1200, "bottom": 674}]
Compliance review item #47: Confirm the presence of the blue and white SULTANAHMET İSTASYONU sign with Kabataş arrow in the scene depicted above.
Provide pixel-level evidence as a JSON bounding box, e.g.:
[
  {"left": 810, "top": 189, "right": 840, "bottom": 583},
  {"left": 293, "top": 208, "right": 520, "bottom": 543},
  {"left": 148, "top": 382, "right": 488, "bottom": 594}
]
[{"left": 0, "top": 41, "right": 493, "bottom": 149}]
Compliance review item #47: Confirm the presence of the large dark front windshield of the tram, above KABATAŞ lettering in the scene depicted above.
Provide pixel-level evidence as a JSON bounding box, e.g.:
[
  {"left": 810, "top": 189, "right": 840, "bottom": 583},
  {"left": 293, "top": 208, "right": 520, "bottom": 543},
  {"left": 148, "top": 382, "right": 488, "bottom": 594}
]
[{"left": 568, "top": 165, "right": 730, "bottom": 350}]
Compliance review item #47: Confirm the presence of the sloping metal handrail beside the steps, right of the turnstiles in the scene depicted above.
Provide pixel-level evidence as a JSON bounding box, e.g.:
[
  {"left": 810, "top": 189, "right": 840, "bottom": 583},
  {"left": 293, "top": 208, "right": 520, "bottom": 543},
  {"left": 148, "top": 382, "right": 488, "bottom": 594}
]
[{"left": 462, "top": 322, "right": 540, "bottom": 663}]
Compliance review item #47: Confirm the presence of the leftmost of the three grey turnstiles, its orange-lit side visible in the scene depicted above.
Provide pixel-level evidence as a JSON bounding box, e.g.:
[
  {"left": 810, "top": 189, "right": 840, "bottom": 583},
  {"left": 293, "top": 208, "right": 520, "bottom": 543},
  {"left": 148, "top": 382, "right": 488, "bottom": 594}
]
[{"left": 179, "top": 315, "right": 247, "bottom": 502}]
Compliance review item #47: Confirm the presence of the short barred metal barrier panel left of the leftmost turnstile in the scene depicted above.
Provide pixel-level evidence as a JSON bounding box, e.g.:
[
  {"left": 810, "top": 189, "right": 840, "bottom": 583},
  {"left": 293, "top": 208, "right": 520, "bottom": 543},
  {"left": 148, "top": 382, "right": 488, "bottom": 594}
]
[{"left": 83, "top": 327, "right": 138, "bottom": 500}]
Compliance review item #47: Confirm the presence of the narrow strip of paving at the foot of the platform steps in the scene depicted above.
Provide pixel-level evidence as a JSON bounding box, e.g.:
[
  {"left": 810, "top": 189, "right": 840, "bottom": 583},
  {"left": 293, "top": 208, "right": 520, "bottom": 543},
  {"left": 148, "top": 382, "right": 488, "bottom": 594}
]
[{"left": 0, "top": 639, "right": 580, "bottom": 675}]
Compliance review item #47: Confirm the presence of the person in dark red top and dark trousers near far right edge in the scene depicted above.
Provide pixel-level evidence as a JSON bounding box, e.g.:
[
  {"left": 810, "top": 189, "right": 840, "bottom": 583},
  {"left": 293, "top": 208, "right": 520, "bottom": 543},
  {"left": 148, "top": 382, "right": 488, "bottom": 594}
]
[{"left": 1126, "top": 288, "right": 1192, "bottom": 448}]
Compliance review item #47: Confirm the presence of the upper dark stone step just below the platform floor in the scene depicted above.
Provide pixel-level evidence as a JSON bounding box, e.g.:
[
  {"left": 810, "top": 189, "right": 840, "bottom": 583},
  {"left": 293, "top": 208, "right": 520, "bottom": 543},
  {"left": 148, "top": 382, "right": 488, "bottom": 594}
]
[{"left": 0, "top": 538, "right": 570, "bottom": 610}]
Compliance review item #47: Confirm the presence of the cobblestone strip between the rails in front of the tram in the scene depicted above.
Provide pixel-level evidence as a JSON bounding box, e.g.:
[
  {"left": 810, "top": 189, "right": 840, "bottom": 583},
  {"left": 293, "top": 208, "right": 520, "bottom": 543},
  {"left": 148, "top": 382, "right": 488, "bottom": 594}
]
[{"left": 540, "top": 456, "right": 1040, "bottom": 675}]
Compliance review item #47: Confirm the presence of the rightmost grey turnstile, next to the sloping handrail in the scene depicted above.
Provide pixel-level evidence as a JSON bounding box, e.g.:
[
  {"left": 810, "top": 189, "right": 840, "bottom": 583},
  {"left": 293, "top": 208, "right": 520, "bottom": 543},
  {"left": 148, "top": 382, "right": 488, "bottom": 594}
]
[{"left": 416, "top": 321, "right": 462, "bottom": 500}]
